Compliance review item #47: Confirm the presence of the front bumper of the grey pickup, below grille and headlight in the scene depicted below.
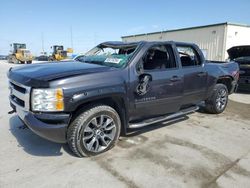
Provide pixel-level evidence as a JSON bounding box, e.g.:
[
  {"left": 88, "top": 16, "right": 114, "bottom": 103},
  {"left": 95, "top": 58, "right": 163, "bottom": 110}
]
[{"left": 11, "top": 103, "right": 70, "bottom": 143}]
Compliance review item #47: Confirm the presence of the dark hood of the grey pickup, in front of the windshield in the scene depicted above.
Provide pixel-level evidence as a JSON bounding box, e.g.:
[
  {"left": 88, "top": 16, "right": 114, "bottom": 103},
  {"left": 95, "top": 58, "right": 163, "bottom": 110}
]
[{"left": 8, "top": 61, "right": 115, "bottom": 87}]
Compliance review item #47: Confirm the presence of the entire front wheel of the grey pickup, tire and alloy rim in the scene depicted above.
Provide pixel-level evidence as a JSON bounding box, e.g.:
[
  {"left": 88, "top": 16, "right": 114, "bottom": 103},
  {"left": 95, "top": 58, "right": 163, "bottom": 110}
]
[{"left": 67, "top": 105, "right": 121, "bottom": 157}]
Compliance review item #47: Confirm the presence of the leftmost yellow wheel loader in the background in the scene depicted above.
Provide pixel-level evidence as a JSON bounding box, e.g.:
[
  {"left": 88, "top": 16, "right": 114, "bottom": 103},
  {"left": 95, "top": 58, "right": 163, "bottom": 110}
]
[{"left": 8, "top": 43, "right": 33, "bottom": 64}]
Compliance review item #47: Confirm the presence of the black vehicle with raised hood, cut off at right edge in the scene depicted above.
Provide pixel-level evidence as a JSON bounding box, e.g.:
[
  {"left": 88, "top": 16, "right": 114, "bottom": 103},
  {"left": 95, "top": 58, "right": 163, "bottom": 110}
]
[{"left": 227, "top": 45, "right": 250, "bottom": 91}]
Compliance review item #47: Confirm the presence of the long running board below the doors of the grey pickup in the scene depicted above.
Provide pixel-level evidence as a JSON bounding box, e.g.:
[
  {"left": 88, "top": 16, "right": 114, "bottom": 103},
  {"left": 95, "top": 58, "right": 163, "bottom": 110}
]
[{"left": 129, "top": 106, "right": 199, "bottom": 129}]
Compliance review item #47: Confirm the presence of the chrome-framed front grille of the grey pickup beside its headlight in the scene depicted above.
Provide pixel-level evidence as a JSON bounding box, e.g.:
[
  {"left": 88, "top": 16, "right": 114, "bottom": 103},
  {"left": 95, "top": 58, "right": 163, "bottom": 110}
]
[{"left": 9, "top": 80, "right": 30, "bottom": 111}]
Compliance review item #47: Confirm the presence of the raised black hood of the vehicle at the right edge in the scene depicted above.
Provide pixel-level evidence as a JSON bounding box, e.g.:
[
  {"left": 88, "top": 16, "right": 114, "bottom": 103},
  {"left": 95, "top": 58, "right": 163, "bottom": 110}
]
[{"left": 227, "top": 46, "right": 250, "bottom": 60}]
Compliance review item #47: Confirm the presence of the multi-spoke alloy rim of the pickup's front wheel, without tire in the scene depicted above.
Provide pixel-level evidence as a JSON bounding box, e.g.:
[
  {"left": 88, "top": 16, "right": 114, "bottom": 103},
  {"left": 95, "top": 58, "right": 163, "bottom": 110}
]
[{"left": 82, "top": 115, "right": 116, "bottom": 152}]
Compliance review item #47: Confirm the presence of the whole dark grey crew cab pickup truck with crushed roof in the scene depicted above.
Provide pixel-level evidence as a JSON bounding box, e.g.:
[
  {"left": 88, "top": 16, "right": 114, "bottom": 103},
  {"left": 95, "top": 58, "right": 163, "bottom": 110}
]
[{"left": 8, "top": 41, "right": 239, "bottom": 157}]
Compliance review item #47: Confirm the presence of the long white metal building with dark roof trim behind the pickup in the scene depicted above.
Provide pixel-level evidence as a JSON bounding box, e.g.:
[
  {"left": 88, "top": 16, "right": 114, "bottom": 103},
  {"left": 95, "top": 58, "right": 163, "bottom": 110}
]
[{"left": 122, "top": 22, "right": 250, "bottom": 61}]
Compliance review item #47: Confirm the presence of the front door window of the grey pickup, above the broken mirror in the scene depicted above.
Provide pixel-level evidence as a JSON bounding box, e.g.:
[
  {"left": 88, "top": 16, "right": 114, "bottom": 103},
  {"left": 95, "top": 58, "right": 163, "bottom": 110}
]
[{"left": 143, "top": 45, "right": 176, "bottom": 70}]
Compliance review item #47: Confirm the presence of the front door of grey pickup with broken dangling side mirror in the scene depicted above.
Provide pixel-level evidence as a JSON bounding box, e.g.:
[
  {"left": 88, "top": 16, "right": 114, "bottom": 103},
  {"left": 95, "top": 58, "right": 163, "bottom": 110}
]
[{"left": 130, "top": 44, "right": 183, "bottom": 119}]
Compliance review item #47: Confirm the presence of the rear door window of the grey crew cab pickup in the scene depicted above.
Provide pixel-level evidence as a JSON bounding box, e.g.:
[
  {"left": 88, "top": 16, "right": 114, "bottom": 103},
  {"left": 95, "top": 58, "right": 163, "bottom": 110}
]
[{"left": 177, "top": 46, "right": 201, "bottom": 67}]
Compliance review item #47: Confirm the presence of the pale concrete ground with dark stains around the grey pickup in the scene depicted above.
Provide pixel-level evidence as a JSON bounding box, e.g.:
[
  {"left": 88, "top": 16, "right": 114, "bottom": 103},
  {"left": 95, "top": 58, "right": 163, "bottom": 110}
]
[{"left": 0, "top": 62, "right": 250, "bottom": 188}]
